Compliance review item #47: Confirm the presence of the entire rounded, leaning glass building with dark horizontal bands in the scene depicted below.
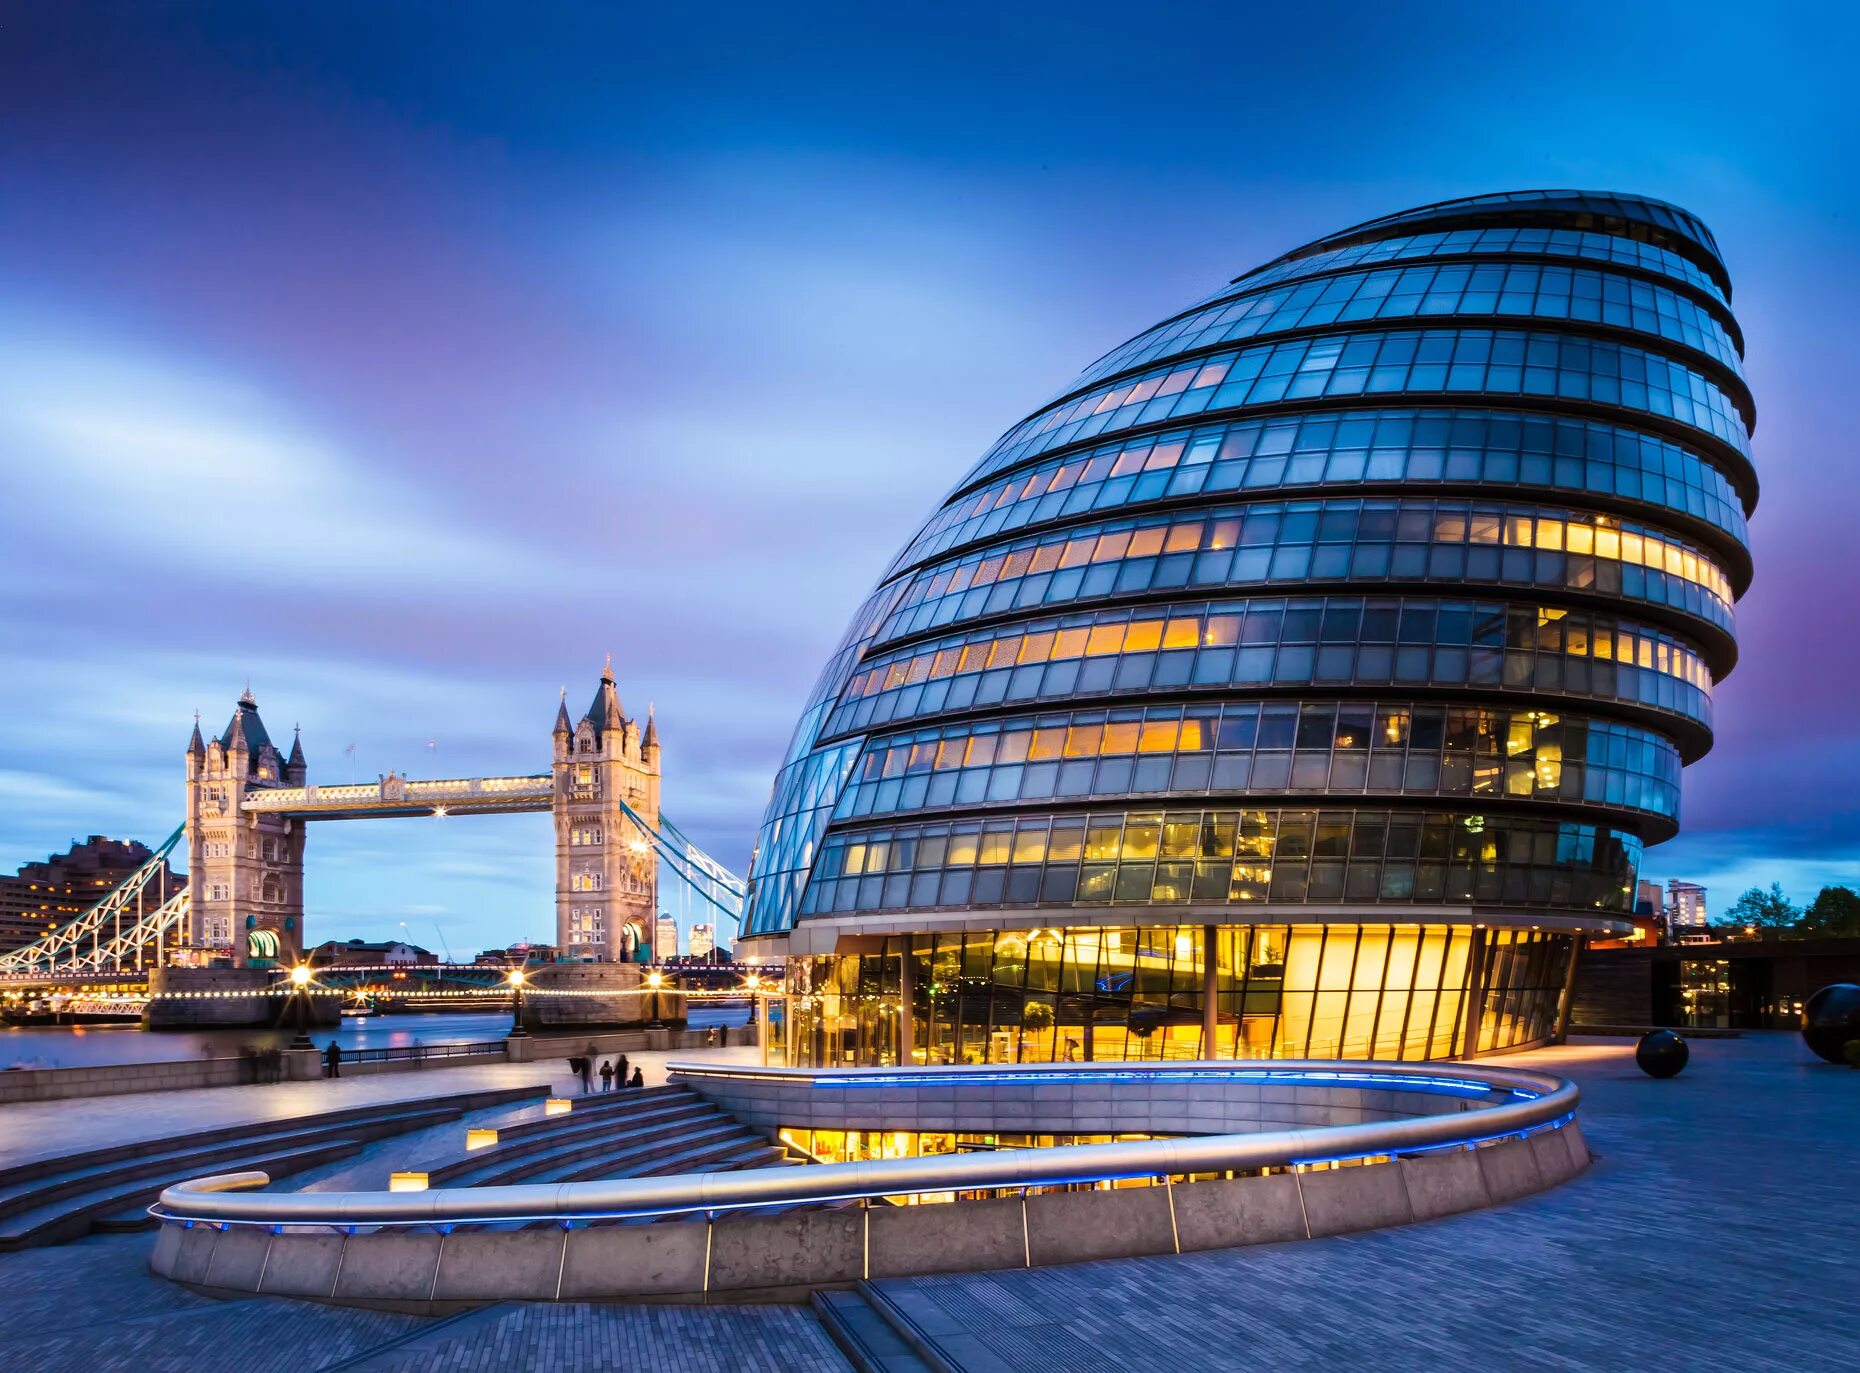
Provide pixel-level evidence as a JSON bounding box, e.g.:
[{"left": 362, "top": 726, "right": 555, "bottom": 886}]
[{"left": 744, "top": 192, "right": 1758, "bottom": 1066}]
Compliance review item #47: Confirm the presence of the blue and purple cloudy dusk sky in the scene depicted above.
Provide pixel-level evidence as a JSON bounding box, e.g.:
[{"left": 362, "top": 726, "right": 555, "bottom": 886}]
[{"left": 0, "top": 0, "right": 1860, "bottom": 953}]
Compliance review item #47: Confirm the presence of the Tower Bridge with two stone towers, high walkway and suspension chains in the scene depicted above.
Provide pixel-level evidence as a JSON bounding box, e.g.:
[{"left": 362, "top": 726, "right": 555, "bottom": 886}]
[{"left": 0, "top": 660, "right": 744, "bottom": 982}]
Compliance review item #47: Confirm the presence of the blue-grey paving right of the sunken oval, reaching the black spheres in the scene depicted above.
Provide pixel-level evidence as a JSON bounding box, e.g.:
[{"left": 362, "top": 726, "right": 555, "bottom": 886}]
[{"left": 874, "top": 1034, "right": 1860, "bottom": 1373}]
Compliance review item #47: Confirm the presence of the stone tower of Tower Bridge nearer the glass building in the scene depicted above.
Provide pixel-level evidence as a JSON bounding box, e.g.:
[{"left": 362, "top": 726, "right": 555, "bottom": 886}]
[{"left": 554, "top": 657, "right": 658, "bottom": 962}]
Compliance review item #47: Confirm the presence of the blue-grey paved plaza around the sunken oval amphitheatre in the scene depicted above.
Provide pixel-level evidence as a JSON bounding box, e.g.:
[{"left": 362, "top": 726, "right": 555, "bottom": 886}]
[{"left": 0, "top": 1034, "right": 1860, "bottom": 1373}]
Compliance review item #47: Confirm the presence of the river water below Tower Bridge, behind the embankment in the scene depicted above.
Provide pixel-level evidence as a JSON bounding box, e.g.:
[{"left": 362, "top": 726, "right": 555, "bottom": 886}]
[{"left": 0, "top": 1006, "right": 750, "bottom": 1070}]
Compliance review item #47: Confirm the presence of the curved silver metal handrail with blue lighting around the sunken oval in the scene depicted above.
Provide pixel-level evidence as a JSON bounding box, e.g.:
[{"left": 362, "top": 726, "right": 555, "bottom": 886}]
[{"left": 149, "top": 1060, "right": 1581, "bottom": 1226}]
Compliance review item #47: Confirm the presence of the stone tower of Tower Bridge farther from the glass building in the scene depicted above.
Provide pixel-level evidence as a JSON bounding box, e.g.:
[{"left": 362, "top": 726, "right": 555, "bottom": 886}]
[{"left": 186, "top": 687, "right": 305, "bottom": 967}]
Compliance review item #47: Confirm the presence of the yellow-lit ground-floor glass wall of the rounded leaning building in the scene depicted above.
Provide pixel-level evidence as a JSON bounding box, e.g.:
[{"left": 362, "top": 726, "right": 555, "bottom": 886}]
[{"left": 789, "top": 925, "right": 1570, "bottom": 1068}]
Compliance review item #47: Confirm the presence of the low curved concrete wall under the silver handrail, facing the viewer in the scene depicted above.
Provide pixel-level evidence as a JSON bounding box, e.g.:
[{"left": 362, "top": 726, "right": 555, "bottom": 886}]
[{"left": 149, "top": 1122, "right": 1588, "bottom": 1313}]
